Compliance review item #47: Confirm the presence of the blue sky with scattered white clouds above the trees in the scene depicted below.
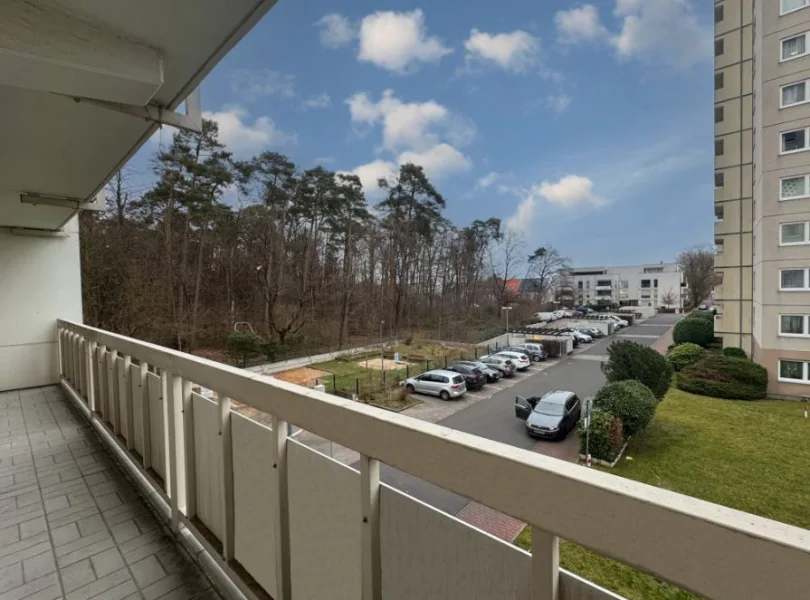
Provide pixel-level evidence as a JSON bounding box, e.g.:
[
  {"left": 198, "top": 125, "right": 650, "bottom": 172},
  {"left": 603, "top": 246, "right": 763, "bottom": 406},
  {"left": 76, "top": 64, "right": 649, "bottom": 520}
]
[{"left": 131, "top": 0, "right": 714, "bottom": 266}]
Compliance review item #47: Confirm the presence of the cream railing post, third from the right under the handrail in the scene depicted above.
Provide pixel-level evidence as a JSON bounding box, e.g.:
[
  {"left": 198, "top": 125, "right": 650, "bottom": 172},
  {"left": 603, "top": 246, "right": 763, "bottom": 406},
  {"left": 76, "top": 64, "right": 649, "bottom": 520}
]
[{"left": 271, "top": 415, "right": 292, "bottom": 600}]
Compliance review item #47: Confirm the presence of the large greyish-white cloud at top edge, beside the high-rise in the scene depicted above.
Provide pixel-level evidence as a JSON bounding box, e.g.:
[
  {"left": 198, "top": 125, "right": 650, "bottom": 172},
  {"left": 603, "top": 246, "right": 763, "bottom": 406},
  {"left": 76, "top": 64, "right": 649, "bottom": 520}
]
[{"left": 611, "top": 0, "right": 714, "bottom": 69}]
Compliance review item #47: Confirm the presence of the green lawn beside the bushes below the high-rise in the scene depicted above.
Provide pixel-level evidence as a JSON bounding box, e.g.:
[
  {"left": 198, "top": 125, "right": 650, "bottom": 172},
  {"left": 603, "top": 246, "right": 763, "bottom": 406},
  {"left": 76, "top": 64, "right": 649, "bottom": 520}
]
[{"left": 515, "top": 389, "right": 810, "bottom": 600}]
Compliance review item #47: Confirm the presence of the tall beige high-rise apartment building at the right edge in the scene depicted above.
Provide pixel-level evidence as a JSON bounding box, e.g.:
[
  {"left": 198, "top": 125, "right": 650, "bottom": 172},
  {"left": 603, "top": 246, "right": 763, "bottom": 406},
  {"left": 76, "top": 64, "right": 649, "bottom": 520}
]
[{"left": 714, "top": 0, "right": 810, "bottom": 397}]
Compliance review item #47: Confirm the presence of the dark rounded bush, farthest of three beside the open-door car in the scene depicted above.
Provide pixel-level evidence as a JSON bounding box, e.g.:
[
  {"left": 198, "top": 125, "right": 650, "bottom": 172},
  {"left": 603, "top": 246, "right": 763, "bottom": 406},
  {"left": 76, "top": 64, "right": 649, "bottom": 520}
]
[{"left": 602, "top": 340, "right": 672, "bottom": 400}]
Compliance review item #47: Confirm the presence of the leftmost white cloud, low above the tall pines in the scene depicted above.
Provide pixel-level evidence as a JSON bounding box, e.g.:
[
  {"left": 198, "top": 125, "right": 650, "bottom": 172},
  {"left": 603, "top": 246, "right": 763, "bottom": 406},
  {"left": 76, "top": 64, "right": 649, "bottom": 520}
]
[{"left": 203, "top": 107, "right": 298, "bottom": 157}]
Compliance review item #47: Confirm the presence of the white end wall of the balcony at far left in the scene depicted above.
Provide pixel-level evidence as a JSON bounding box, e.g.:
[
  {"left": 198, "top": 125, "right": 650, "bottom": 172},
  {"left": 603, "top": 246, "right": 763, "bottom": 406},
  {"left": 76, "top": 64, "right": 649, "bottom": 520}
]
[{"left": 0, "top": 218, "right": 82, "bottom": 391}]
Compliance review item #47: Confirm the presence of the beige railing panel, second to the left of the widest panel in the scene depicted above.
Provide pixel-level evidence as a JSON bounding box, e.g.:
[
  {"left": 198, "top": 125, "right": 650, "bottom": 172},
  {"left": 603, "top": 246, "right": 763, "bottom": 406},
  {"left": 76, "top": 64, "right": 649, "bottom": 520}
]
[{"left": 231, "top": 412, "right": 280, "bottom": 598}]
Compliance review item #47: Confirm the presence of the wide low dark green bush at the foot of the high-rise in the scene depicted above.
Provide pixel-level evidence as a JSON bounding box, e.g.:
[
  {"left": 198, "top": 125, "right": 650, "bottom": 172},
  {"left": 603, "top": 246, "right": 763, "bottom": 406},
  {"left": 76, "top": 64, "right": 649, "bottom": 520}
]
[{"left": 675, "top": 354, "right": 768, "bottom": 400}]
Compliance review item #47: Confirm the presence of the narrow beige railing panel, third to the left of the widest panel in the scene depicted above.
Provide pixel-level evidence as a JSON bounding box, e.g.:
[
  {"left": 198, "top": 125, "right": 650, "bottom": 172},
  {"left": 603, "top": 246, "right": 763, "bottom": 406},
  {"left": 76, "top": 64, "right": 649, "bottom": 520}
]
[{"left": 191, "top": 394, "right": 223, "bottom": 540}]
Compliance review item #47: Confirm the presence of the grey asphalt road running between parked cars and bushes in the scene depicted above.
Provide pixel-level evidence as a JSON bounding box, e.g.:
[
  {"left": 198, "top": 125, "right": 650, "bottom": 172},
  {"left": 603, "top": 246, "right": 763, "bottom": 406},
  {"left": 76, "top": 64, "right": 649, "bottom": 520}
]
[{"left": 381, "top": 314, "right": 681, "bottom": 515}]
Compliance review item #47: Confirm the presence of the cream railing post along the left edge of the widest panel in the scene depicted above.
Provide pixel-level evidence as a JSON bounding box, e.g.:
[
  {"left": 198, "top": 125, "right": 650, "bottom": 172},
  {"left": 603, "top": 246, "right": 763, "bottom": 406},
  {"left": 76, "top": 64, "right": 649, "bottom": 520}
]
[{"left": 360, "top": 455, "right": 382, "bottom": 600}]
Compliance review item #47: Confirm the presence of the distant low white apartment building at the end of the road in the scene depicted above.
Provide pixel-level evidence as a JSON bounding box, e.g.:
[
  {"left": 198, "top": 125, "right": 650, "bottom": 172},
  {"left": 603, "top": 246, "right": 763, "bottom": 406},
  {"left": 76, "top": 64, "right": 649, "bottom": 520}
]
[{"left": 566, "top": 263, "right": 686, "bottom": 308}]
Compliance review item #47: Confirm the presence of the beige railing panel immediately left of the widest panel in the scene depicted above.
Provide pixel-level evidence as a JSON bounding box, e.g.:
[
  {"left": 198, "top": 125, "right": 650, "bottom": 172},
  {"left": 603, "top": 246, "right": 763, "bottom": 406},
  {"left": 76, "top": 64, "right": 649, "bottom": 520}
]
[{"left": 287, "top": 440, "right": 362, "bottom": 600}]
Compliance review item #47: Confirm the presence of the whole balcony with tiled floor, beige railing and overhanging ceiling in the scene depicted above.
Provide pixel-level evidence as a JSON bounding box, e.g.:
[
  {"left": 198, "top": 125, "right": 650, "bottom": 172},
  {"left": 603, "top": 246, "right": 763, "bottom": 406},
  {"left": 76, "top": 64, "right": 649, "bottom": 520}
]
[{"left": 0, "top": 0, "right": 810, "bottom": 600}]
